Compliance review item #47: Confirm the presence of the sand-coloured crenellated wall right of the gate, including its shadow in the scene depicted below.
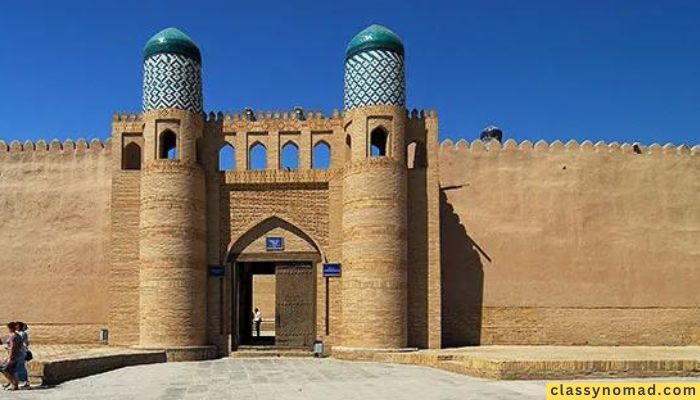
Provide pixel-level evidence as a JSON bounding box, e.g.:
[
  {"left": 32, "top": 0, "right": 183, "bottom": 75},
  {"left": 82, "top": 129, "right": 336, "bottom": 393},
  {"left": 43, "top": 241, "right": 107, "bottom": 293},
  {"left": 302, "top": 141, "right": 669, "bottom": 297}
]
[{"left": 440, "top": 141, "right": 700, "bottom": 346}]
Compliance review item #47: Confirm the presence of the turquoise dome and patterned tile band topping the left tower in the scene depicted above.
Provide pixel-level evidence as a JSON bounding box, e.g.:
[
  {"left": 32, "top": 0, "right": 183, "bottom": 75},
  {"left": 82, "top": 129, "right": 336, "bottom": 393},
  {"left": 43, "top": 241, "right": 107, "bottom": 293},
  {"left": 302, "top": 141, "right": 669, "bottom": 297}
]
[{"left": 143, "top": 28, "right": 203, "bottom": 113}]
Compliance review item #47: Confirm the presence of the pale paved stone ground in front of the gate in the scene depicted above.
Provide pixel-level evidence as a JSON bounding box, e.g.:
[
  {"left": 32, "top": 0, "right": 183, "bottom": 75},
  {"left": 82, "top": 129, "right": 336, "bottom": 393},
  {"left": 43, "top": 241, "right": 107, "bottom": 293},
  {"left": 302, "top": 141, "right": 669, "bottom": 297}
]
[{"left": 5, "top": 359, "right": 697, "bottom": 400}]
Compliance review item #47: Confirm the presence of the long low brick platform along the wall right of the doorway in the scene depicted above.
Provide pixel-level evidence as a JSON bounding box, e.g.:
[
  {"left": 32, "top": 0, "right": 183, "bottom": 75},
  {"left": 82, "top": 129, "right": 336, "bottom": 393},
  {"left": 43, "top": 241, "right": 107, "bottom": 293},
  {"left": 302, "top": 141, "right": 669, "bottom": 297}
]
[{"left": 331, "top": 346, "right": 700, "bottom": 380}]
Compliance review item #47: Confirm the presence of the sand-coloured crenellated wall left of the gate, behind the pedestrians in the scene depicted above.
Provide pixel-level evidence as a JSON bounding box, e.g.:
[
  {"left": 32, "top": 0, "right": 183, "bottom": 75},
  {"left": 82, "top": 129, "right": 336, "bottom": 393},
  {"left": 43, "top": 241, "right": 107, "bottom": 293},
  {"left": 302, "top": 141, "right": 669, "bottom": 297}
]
[{"left": 0, "top": 140, "right": 111, "bottom": 343}]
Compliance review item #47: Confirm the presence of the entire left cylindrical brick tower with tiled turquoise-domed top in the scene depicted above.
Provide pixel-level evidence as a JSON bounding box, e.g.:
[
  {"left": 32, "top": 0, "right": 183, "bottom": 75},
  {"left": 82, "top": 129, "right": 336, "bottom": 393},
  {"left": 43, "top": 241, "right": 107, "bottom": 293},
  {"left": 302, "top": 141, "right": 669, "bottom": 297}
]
[{"left": 139, "top": 28, "right": 206, "bottom": 348}]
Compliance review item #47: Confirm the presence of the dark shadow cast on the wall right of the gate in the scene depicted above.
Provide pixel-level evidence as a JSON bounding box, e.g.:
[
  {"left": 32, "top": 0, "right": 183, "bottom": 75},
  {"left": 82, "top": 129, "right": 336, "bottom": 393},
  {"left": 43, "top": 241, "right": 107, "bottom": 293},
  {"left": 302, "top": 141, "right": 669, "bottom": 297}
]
[{"left": 440, "top": 186, "right": 491, "bottom": 347}]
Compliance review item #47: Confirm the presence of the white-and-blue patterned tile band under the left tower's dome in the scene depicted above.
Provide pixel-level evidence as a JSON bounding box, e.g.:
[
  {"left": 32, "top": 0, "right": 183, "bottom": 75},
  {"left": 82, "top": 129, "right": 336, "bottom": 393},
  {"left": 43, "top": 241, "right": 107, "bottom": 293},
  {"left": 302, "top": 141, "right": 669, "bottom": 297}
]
[{"left": 143, "top": 54, "right": 202, "bottom": 113}]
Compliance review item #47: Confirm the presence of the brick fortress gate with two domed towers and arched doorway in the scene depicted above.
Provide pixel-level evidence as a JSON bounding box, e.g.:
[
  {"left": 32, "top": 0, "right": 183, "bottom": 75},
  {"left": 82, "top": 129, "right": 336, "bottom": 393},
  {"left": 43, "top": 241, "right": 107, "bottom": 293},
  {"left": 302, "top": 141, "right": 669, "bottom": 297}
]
[{"left": 110, "top": 25, "right": 441, "bottom": 358}]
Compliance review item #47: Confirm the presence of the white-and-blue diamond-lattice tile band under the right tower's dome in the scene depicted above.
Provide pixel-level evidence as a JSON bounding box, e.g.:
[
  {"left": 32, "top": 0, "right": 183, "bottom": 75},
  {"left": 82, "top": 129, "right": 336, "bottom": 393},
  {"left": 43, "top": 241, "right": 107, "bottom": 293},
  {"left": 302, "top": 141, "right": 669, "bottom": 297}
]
[{"left": 344, "top": 50, "right": 406, "bottom": 110}]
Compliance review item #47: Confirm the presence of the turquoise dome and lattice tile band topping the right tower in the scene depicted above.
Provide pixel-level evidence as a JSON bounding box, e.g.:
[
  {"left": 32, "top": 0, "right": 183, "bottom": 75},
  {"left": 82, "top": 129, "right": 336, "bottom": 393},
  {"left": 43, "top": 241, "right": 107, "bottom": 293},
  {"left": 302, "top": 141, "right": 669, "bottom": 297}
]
[{"left": 344, "top": 25, "right": 406, "bottom": 111}]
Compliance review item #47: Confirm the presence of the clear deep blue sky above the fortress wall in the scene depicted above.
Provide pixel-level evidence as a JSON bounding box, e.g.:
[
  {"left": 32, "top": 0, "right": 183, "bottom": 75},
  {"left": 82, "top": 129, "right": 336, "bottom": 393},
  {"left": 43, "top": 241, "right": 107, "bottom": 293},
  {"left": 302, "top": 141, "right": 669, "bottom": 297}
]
[{"left": 0, "top": 0, "right": 700, "bottom": 145}]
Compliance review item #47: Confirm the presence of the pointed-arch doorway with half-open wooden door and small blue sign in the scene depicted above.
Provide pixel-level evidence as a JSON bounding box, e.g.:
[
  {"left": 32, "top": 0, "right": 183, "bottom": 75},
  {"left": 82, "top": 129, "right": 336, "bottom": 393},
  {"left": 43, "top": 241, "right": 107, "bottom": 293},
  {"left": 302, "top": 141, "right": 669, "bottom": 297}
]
[{"left": 227, "top": 217, "right": 323, "bottom": 348}]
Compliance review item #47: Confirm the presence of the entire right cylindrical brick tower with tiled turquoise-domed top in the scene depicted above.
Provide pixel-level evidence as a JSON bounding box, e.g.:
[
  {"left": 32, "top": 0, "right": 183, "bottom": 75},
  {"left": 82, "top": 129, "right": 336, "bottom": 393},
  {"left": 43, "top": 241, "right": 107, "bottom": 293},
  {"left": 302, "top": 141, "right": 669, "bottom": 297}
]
[{"left": 341, "top": 25, "right": 407, "bottom": 349}]
